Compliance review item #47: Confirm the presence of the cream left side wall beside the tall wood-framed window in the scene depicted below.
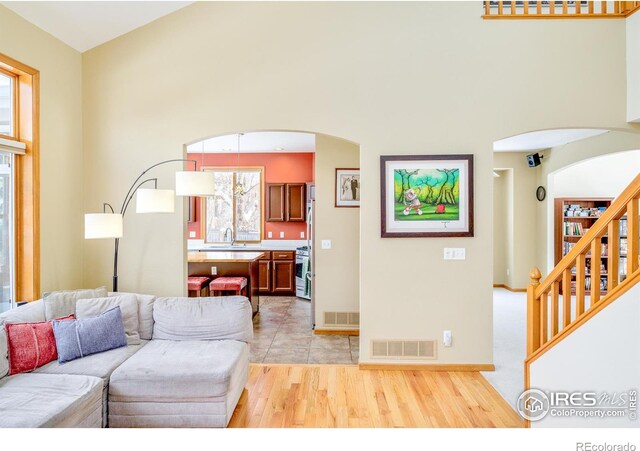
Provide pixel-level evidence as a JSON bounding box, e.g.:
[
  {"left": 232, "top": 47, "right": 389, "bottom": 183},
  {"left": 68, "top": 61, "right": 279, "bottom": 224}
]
[{"left": 0, "top": 5, "right": 84, "bottom": 292}]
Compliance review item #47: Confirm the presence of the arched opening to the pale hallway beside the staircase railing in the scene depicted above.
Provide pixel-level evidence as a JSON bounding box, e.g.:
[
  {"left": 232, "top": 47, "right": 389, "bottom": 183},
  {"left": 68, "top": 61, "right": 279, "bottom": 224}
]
[{"left": 485, "top": 128, "right": 640, "bottom": 410}]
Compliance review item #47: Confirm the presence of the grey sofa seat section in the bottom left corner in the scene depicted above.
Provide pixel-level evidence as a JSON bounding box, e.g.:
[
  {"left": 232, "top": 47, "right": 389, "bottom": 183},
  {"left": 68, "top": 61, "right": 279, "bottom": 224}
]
[{"left": 0, "top": 374, "right": 102, "bottom": 428}]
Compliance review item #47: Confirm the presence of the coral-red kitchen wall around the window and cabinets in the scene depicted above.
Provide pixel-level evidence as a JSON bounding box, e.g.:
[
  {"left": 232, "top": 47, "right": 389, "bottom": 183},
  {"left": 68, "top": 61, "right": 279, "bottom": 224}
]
[{"left": 187, "top": 152, "right": 315, "bottom": 240}]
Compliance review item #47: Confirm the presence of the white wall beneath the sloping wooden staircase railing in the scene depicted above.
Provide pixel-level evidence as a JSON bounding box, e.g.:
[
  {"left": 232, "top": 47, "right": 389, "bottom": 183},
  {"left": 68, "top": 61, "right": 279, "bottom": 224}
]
[{"left": 530, "top": 284, "right": 640, "bottom": 428}]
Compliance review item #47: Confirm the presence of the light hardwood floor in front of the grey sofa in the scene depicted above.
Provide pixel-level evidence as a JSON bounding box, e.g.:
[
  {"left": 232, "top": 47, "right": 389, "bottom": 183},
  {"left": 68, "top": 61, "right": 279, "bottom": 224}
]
[{"left": 229, "top": 364, "right": 524, "bottom": 428}]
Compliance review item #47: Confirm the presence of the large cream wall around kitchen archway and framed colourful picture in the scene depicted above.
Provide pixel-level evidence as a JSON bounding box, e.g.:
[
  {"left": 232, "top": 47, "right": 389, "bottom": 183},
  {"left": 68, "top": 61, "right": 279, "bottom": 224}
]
[{"left": 83, "top": 2, "right": 628, "bottom": 364}]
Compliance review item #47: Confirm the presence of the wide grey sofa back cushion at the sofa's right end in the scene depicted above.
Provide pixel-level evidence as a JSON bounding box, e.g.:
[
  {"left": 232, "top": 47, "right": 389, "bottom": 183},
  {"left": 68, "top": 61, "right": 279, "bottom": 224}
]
[{"left": 153, "top": 296, "right": 253, "bottom": 343}]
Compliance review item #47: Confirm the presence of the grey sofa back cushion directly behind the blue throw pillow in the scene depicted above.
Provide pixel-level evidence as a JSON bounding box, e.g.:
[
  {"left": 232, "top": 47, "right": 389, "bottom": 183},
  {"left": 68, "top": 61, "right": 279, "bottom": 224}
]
[{"left": 76, "top": 294, "right": 140, "bottom": 345}]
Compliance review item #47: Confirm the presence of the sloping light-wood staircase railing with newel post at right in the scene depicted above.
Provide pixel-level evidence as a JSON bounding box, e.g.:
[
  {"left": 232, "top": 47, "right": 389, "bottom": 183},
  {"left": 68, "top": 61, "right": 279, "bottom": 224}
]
[{"left": 525, "top": 174, "right": 640, "bottom": 400}]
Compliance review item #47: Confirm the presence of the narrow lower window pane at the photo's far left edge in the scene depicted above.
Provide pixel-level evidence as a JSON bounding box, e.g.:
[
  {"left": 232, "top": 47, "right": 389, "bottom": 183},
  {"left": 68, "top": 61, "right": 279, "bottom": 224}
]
[{"left": 0, "top": 151, "right": 14, "bottom": 312}]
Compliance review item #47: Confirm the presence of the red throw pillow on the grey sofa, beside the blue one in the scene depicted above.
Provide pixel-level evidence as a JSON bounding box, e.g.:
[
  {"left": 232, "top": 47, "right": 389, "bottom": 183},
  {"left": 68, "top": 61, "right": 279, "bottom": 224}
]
[{"left": 4, "top": 315, "right": 75, "bottom": 375}]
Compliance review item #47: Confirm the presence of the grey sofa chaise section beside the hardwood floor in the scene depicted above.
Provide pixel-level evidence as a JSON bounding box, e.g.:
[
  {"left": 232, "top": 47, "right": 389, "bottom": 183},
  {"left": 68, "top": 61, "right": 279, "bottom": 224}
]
[{"left": 109, "top": 340, "right": 249, "bottom": 427}]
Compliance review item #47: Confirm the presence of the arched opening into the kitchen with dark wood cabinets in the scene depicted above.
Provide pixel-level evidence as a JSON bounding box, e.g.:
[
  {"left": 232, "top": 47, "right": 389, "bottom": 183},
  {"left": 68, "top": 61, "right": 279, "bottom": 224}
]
[{"left": 184, "top": 130, "right": 360, "bottom": 364}]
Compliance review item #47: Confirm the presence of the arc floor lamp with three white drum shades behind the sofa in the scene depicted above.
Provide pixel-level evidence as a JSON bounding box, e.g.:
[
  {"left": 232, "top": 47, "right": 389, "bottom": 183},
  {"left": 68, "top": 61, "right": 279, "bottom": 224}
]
[{"left": 84, "top": 158, "right": 214, "bottom": 291}]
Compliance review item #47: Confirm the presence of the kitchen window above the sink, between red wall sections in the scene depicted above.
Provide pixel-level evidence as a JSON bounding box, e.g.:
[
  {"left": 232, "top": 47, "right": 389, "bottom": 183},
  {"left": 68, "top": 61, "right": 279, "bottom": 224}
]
[{"left": 202, "top": 168, "right": 263, "bottom": 243}]
